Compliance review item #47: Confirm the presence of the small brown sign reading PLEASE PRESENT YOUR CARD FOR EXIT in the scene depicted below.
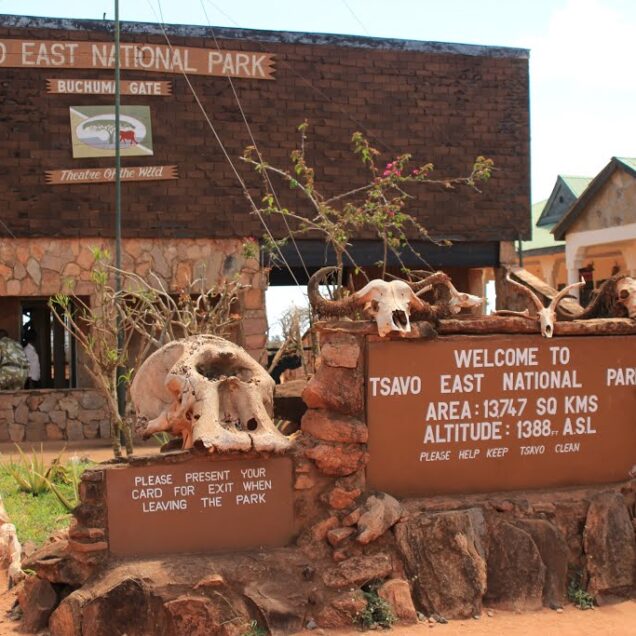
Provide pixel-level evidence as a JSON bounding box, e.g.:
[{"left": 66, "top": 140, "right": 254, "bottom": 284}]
[{"left": 106, "top": 457, "right": 293, "bottom": 556}]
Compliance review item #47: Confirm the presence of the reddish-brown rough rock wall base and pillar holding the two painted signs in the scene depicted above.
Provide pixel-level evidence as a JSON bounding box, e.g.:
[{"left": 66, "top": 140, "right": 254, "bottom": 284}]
[{"left": 13, "top": 323, "right": 636, "bottom": 635}]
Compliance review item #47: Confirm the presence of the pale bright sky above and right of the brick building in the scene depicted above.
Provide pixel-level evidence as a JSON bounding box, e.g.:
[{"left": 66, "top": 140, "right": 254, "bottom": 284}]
[{"left": 0, "top": 0, "right": 636, "bottom": 330}]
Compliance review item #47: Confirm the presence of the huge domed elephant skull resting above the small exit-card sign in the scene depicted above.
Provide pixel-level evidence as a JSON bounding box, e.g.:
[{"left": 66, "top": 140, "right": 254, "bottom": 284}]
[{"left": 131, "top": 335, "right": 290, "bottom": 452}]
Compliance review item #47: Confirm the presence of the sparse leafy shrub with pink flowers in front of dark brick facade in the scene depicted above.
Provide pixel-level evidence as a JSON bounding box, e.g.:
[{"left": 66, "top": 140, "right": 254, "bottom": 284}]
[{"left": 242, "top": 121, "right": 493, "bottom": 294}]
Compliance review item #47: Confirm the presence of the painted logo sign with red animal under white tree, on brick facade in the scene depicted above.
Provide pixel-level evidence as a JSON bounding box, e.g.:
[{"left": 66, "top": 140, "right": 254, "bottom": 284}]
[{"left": 69, "top": 106, "right": 153, "bottom": 159}]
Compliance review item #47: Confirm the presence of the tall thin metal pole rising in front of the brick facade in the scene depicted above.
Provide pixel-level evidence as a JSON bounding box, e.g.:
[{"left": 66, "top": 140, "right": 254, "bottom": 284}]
[{"left": 115, "top": 0, "right": 126, "bottom": 424}]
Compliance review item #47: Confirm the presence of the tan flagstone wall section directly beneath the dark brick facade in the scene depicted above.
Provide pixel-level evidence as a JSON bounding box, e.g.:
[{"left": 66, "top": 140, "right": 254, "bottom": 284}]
[{"left": 0, "top": 238, "right": 267, "bottom": 368}]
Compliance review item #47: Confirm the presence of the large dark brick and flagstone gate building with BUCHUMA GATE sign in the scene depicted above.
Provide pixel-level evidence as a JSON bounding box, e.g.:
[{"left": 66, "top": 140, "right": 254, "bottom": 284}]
[{"left": 0, "top": 16, "right": 530, "bottom": 439}]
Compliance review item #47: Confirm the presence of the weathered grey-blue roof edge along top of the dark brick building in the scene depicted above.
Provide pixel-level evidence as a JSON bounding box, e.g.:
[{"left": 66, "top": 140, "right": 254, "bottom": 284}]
[{"left": 0, "top": 14, "right": 530, "bottom": 59}]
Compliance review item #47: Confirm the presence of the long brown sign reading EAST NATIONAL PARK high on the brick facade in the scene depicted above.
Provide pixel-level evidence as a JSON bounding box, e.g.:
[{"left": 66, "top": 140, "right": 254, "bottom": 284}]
[{"left": 0, "top": 39, "right": 274, "bottom": 79}]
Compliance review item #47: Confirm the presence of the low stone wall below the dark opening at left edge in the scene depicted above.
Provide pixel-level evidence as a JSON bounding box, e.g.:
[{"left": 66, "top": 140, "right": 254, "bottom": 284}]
[{"left": 0, "top": 389, "right": 110, "bottom": 442}]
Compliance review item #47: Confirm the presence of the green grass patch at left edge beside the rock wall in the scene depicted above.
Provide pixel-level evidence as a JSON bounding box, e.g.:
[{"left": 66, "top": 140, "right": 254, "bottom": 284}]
[{"left": 0, "top": 463, "right": 92, "bottom": 545}]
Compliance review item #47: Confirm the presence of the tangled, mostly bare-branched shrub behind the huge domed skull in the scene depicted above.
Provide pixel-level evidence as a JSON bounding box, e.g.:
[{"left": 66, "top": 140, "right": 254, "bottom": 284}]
[{"left": 49, "top": 248, "right": 247, "bottom": 458}]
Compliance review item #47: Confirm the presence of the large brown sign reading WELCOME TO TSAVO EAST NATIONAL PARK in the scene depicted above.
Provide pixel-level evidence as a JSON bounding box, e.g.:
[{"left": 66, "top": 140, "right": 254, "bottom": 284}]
[{"left": 367, "top": 336, "right": 636, "bottom": 496}]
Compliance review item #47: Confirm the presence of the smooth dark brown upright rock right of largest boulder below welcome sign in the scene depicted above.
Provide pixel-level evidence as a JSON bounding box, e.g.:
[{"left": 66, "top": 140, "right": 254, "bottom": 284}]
[{"left": 486, "top": 521, "right": 546, "bottom": 611}]
